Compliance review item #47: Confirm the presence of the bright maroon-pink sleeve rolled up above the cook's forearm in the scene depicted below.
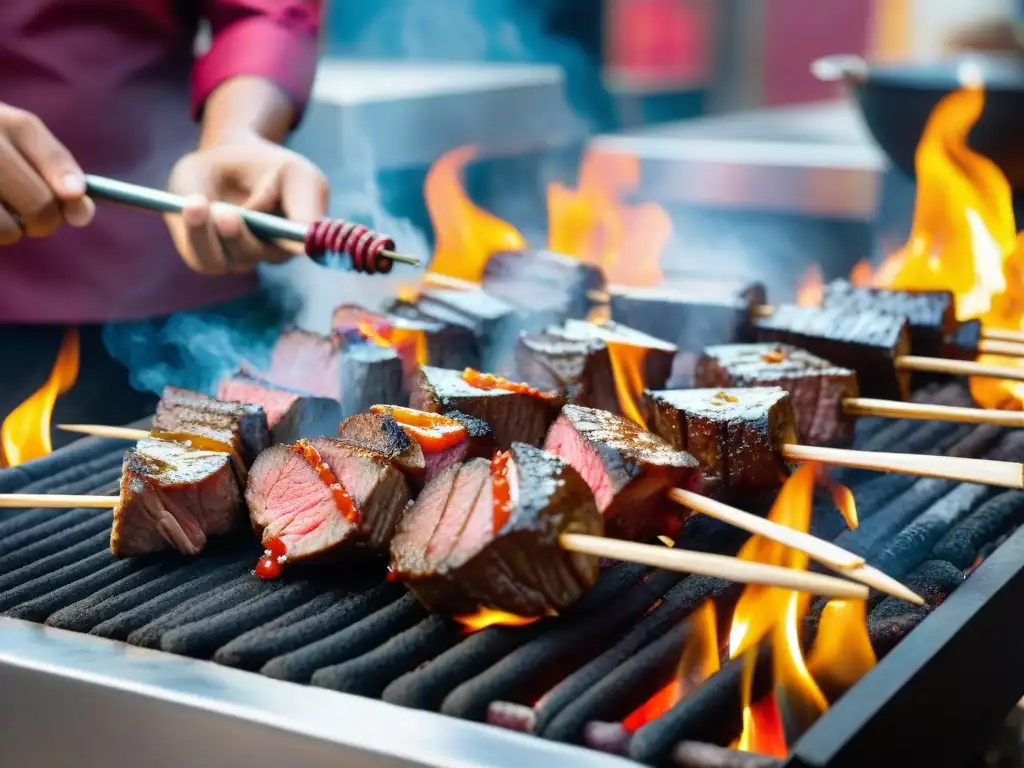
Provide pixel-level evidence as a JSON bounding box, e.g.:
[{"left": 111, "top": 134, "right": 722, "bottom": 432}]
[{"left": 191, "top": 0, "right": 323, "bottom": 118}]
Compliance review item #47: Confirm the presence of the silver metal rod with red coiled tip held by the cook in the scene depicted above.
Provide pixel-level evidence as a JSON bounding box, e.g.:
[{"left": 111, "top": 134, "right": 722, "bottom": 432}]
[{"left": 77, "top": 174, "right": 420, "bottom": 274}]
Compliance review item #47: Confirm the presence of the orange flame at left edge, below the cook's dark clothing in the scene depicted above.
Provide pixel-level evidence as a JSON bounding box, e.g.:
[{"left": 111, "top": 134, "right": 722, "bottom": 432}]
[{"left": 0, "top": 328, "right": 79, "bottom": 467}]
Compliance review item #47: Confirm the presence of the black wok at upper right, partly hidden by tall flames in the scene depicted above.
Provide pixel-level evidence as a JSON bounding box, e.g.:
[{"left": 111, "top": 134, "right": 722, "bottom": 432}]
[{"left": 811, "top": 53, "right": 1024, "bottom": 197}]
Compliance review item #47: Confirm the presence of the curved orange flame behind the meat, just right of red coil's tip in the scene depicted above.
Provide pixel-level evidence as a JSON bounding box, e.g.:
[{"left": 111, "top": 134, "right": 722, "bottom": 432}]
[{"left": 423, "top": 146, "right": 526, "bottom": 283}]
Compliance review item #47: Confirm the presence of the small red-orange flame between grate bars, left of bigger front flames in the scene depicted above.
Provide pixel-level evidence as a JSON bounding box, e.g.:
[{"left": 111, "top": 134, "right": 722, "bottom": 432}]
[{"left": 623, "top": 600, "right": 719, "bottom": 733}]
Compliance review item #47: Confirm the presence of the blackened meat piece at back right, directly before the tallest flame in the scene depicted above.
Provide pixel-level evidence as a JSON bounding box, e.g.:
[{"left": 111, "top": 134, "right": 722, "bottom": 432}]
[{"left": 821, "top": 280, "right": 957, "bottom": 357}]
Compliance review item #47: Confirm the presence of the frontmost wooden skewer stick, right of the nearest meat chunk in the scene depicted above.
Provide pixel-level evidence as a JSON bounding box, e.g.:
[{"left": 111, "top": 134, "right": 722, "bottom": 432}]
[{"left": 558, "top": 534, "right": 867, "bottom": 600}]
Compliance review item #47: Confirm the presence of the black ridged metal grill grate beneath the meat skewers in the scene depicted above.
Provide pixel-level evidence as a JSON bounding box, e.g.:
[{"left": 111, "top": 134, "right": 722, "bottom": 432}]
[{"left": 0, "top": 387, "right": 1024, "bottom": 764}]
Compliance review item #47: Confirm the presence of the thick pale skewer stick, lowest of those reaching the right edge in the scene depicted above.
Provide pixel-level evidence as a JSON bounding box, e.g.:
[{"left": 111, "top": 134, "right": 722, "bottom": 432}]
[{"left": 782, "top": 444, "right": 1024, "bottom": 488}]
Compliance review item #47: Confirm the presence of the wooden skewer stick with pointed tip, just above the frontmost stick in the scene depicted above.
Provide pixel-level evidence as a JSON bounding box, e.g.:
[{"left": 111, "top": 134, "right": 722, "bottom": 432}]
[{"left": 669, "top": 488, "right": 925, "bottom": 605}]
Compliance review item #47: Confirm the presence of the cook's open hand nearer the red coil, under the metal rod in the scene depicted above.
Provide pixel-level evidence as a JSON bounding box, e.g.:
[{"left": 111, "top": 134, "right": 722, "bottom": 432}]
[{"left": 166, "top": 136, "right": 329, "bottom": 274}]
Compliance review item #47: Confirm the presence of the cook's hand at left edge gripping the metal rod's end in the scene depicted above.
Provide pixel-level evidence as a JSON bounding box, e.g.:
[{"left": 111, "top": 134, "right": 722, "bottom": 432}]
[{"left": 0, "top": 102, "right": 96, "bottom": 246}]
